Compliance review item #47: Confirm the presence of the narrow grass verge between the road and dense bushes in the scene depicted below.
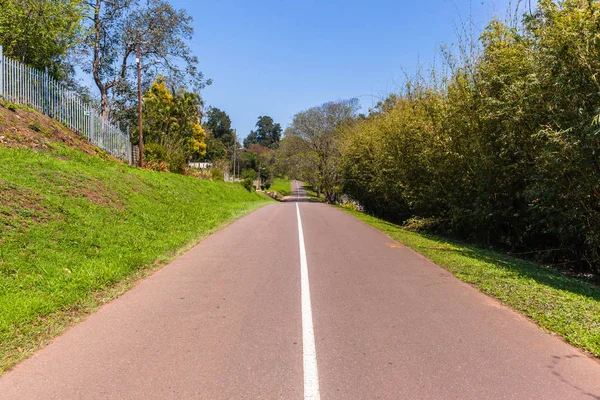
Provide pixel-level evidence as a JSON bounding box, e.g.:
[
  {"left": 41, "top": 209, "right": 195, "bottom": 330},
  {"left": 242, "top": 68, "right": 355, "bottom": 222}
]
[{"left": 345, "top": 209, "right": 600, "bottom": 357}]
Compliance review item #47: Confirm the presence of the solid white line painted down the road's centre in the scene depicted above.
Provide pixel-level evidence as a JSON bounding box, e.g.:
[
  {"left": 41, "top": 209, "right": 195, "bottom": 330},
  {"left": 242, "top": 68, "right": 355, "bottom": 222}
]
[{"left": 296, "top": 203, "right": 321, "bottom": 400}]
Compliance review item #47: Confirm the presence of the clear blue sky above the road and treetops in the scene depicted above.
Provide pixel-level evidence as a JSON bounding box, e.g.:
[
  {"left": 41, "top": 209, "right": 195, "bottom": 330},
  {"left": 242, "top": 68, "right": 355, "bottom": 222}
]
[{"left": 172, "top": 0, "right": 510, "bottom": 138}]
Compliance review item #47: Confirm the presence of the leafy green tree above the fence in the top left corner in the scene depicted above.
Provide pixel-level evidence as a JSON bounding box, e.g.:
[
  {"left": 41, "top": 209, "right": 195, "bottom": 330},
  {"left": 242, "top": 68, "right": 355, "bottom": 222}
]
[{"left": 0, "top": 0, "right": 84, "bottom": 81}]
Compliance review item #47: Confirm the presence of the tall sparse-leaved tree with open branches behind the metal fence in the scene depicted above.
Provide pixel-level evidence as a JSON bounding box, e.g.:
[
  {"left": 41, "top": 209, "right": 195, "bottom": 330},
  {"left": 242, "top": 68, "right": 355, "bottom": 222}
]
[{"left": 83, "top": 0, "right": 210, "bottom": 119}]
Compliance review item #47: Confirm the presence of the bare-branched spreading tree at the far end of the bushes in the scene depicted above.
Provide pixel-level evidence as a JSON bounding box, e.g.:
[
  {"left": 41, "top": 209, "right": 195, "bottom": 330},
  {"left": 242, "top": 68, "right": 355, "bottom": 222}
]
[{"left": 285, "top": 99, "right": 360, "bottom": 203}]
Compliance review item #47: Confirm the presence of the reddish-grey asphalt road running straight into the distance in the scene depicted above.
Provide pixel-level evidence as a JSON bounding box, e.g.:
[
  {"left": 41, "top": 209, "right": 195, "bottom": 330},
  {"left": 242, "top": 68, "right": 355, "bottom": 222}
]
[{"left": 0, "top": 183, "right": 600, "bottom": 400}]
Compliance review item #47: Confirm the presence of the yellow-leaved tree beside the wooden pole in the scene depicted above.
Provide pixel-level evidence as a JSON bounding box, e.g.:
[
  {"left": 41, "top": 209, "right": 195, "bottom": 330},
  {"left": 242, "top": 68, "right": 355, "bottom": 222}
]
[{"left": 144, "top": 77, "right": 206, "bottom": 171}]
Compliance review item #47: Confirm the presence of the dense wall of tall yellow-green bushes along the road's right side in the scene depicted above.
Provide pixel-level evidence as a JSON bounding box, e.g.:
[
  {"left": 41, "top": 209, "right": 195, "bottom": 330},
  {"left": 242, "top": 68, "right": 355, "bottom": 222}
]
[{"left": 342, "top": 0, "right": 600, "bottom": 275}]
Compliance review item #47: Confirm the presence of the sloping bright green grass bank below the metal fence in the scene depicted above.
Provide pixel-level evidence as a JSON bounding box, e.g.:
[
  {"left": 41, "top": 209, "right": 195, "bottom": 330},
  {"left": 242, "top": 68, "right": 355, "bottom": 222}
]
[{"left": 0, "top": 144, "right": 269, "bottom": 373}]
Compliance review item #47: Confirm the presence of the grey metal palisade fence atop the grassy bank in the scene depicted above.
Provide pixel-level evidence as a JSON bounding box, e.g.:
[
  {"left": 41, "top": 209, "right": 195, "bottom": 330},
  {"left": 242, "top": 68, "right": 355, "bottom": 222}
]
[{"left": 0, "top": 46, "right": 132, "bottom": 163}]
